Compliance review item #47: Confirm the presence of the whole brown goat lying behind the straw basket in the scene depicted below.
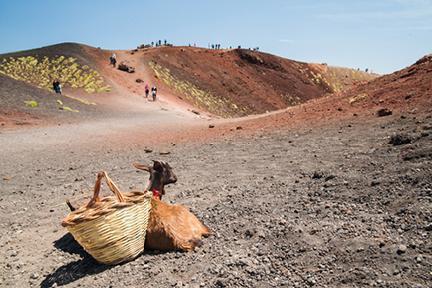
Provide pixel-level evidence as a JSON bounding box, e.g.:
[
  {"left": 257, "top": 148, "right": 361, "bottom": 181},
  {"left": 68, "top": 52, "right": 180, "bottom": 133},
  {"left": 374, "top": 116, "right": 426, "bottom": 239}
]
[{"left": 66, "top": 161, "right": 210, "bottom": 251}]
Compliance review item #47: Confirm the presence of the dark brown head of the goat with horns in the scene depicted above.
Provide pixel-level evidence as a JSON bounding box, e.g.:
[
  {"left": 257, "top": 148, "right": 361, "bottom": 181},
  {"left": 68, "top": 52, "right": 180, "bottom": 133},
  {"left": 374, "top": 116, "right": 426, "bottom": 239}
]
[{"left": 133, "top": 160, "right": 177, "bottom": 198}]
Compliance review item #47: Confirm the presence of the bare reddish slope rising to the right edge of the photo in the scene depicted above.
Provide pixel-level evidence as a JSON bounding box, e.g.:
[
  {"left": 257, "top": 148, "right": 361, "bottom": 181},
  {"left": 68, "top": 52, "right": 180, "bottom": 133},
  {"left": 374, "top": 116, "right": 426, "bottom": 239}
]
[{"left": 220, "top": 55, "right": 432, "bottom": 133}]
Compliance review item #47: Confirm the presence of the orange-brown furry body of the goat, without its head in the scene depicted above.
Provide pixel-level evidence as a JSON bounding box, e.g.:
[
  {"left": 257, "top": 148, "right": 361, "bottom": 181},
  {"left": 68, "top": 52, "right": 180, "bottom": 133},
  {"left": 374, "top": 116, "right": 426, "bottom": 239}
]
[{"left": 145, "top": 199, "right": 210, "bottom": 251}]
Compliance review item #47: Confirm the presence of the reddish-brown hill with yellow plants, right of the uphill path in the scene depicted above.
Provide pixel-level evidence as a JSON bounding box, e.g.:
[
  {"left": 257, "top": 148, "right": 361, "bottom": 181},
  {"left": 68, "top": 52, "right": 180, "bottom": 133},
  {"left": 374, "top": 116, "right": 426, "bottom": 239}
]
[{"left": 139, "top": 47, "right": 375, "bottom": 116}]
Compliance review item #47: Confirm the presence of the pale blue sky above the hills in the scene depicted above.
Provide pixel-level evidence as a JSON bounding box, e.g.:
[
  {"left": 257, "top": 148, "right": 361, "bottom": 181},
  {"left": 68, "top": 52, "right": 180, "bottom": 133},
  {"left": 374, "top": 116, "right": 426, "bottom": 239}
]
[{"left": 0, "top": 0, "right": 432, "bottom": 73}]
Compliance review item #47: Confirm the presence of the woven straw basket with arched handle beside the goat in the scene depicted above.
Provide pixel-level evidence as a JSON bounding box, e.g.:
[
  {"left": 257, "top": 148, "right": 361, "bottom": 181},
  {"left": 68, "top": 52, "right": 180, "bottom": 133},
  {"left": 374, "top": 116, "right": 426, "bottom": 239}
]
[{"left": 62, "top": 172, "right": 151, "bottom": 265}]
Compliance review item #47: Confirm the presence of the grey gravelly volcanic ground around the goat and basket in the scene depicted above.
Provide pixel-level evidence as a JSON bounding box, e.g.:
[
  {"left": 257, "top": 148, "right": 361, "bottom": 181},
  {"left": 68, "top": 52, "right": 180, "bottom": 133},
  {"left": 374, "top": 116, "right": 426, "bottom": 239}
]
[{"left": 0, "top": 114, "right": 432, "bottom": 287}]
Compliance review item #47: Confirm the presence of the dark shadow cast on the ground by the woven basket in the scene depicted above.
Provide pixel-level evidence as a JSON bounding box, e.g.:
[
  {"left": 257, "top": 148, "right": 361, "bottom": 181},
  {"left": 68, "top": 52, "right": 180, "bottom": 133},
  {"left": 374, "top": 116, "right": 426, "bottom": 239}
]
[{"left": 40, "top": 233, "right": 112, "bottom": 288}]
